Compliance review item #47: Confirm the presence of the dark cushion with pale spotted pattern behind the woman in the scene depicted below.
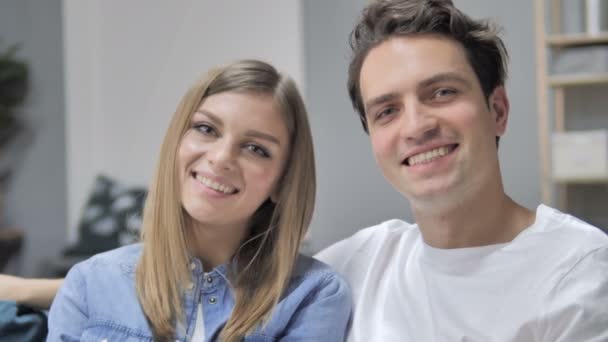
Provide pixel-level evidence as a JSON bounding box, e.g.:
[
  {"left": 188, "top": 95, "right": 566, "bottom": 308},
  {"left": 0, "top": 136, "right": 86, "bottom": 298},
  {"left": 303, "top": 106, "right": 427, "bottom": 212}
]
[{"left": 64, "top": 175, "right": 147, "bottom": 256}]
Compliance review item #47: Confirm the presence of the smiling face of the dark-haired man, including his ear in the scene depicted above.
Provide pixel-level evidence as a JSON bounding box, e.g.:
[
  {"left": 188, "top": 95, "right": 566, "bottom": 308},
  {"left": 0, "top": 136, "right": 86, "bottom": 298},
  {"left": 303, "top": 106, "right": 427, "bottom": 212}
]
[{"left": 360, "top": 35, "right": 509, "bottom": 206}]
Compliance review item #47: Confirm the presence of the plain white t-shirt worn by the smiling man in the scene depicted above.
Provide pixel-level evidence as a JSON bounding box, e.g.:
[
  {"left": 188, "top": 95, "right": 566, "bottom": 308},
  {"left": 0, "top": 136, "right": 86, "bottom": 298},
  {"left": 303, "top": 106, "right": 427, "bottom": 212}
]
[{"left": 316, "top": 205, "right": 608, "bottom": 342}]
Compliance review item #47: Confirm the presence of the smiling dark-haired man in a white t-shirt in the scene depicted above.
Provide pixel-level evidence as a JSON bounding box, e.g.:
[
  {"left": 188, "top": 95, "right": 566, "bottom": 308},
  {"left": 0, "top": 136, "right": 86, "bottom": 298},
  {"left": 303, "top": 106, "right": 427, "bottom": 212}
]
[{"left": 318, "top": 0, "right": 608, "bottom": 342}]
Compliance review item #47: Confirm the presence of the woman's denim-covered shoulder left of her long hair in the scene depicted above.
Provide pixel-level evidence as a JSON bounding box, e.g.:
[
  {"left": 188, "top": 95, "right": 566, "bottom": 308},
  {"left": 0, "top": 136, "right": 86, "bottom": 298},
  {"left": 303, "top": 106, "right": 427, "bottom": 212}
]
[{"left": 49, "top": 245, "right": 152, "bottom": 341}]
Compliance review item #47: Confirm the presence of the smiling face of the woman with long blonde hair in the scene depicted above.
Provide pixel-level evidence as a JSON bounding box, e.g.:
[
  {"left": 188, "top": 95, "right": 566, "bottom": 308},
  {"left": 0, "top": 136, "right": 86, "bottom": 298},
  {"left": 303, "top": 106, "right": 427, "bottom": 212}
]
[{"left": 177, "top": 92, "right": 289, "bottom": 229}]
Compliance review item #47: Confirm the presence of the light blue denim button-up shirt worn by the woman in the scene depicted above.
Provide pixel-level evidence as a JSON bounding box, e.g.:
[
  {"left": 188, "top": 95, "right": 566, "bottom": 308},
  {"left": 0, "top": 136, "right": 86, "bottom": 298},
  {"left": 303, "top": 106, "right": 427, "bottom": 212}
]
[{"left": 47, "top": 244, "right": 352, "bottom": 342}]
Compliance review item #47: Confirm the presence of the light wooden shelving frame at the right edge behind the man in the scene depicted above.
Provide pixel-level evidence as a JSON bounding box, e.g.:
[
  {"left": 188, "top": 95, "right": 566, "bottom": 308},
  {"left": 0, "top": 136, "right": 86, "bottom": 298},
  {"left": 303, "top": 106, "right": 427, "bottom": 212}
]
[{"left": 535, "top": 0, "right": 608, "bottom": 210}]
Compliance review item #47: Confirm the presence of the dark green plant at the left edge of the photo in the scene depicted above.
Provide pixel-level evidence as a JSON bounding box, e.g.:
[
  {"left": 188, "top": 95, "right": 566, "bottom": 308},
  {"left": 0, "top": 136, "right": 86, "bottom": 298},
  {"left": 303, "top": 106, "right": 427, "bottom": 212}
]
[{"left": 0, "top": 45, "right": 28, "bottom": 152}]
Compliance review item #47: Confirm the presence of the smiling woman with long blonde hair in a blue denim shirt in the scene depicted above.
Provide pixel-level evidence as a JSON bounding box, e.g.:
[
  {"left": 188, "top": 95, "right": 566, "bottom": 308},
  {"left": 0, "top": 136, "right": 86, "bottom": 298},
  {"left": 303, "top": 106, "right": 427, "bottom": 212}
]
[{"left": 48, "top": 61, "right": 351, "bottom": 342}]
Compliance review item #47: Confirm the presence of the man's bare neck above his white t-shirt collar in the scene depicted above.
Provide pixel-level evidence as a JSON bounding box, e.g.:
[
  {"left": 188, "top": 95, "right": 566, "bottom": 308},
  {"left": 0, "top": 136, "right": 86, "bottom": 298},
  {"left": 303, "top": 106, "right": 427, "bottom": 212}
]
[{"left": 412, "top": 186, "right": 535, "bottom": 248}]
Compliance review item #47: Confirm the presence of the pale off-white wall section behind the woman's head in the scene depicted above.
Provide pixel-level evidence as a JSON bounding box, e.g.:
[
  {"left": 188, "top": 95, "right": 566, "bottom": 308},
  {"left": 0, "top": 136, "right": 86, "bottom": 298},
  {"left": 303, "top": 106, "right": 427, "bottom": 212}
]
[{"left": 63, "top": 0, "right": 304, "bottom": 238}]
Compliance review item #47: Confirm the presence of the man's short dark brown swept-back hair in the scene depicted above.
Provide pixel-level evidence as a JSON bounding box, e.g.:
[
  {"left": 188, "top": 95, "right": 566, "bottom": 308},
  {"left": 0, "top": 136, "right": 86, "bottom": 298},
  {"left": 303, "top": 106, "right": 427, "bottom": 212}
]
[{"left": 348, "top": 0, "right": 508, "bottom": 136}]
